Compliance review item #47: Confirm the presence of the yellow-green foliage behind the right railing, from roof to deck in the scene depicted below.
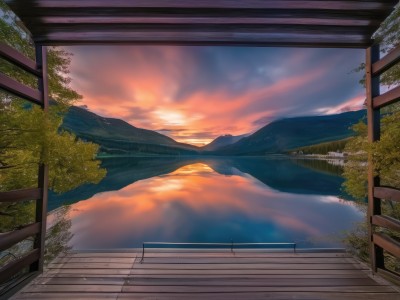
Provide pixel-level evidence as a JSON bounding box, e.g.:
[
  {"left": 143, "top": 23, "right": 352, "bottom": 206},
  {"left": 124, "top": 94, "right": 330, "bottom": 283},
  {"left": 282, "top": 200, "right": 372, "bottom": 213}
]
[{"left": 343, "top": 4, "right": 400, "bottom": 272}]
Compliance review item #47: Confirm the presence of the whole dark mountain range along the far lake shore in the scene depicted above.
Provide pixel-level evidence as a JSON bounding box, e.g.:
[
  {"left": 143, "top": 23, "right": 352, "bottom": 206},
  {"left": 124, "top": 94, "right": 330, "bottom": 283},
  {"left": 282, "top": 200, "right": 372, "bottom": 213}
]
[{"left": 62, "top": 106, "right": 366, "bottom": 156}]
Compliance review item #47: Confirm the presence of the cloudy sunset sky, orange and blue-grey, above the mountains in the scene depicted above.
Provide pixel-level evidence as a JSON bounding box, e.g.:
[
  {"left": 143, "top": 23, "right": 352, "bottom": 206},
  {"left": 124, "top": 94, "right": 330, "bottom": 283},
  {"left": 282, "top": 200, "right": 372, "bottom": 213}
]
[{"left": 66, "top": 46, "right": 365, "bottom": 146}]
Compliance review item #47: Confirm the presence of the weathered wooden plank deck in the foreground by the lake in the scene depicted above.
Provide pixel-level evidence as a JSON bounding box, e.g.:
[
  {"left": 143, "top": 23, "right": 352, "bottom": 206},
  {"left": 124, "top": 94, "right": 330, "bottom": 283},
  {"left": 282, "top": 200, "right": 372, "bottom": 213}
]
[{"left": 12, "top": 250, "right": 400, "bottom": 300}]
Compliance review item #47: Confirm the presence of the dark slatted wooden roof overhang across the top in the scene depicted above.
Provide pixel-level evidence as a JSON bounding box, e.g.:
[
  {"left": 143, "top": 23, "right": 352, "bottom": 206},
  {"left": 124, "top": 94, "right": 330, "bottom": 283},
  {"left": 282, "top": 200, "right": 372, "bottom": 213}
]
[{"left": 5, "top": 0, "right": 398, "bottom": 48}]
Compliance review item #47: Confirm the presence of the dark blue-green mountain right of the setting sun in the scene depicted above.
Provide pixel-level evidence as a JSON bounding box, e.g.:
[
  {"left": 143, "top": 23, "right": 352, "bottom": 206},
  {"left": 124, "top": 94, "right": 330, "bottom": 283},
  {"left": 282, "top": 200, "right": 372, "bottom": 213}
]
[{"left": 214, "top": 110, "right": 366, "bottom": 155}]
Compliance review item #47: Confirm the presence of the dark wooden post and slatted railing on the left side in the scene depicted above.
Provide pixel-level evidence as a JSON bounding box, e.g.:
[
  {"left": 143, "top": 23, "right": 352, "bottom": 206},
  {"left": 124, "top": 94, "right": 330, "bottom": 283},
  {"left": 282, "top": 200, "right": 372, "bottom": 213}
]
[{"left": 0, "top": 43, "right": 49, "bottom": 298}]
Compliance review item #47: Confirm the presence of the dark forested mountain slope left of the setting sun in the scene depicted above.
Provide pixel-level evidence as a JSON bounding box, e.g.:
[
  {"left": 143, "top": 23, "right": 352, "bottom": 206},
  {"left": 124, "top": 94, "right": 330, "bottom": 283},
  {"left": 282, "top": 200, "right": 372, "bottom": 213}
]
[{"left": 62, "top": 106, "right": 198, "bottom": 155}]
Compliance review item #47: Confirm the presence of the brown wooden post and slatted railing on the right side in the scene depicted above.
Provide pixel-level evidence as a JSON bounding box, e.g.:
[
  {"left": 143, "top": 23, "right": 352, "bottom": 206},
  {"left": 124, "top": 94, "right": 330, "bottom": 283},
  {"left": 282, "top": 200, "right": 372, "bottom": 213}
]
[{"left": 366, "top": 45, "right": 400, "bottom": 281}]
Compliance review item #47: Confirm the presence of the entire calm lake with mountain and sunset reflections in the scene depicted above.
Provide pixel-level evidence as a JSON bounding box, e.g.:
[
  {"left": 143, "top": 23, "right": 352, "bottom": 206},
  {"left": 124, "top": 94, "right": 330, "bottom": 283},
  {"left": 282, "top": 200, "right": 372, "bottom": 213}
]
[{"left": 50, "top": 158, "right": 363, "bottom": 249}]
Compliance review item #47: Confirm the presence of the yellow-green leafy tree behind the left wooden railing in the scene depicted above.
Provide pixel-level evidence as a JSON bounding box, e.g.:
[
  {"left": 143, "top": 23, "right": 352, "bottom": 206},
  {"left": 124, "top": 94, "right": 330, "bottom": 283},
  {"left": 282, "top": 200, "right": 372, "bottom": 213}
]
[{"left": 0, "top": 0, "right": 106, "bottom": 231}]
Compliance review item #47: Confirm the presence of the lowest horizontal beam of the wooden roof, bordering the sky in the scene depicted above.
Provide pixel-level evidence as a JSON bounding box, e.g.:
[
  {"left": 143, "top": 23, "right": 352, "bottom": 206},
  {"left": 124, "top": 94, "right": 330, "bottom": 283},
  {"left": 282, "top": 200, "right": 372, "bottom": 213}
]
[{"left": 35, "top": 31, "right": 371, "bottom": 48}]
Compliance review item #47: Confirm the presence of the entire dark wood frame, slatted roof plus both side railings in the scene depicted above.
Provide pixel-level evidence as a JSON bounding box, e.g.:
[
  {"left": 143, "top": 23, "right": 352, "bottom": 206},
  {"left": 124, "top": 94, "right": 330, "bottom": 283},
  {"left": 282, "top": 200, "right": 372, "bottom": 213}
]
[{"left": 0, "top": 0, "right": 400, "bottom": 296}]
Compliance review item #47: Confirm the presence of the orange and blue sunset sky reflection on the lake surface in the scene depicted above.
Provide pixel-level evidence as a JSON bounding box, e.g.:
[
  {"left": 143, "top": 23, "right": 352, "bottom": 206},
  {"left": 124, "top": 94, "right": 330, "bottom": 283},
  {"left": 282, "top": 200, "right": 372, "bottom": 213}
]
[{"left": 61, "top": 163, "right": 362, "bottom": 249}]
